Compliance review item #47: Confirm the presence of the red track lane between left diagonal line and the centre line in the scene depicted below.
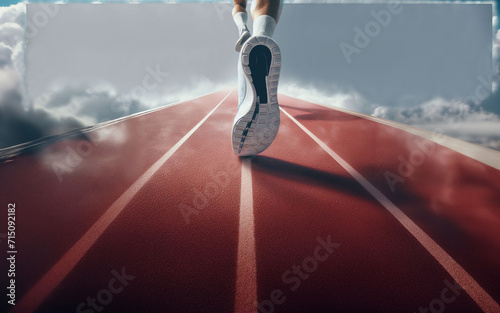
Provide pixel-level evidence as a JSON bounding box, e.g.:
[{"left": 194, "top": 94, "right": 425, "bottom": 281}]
[{"left": 31, "top": 92, "right": 241, "bottom": 312}]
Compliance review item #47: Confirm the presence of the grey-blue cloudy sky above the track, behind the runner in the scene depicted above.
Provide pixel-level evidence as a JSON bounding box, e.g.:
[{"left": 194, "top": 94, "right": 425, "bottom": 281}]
[{"left": 0, "top": 1, "right": 500, "bottom": 150}]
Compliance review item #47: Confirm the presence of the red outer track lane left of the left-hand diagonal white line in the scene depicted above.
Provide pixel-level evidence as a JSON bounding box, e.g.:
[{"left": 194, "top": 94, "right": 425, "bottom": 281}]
[{"left": 0, "top": 91, "right": 228, "bottom": 309}]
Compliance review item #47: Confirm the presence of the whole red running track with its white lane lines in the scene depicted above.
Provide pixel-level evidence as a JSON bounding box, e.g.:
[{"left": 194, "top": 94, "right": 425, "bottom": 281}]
[{"left": 0, "top": 91, "right": 500, "bottom": 313}]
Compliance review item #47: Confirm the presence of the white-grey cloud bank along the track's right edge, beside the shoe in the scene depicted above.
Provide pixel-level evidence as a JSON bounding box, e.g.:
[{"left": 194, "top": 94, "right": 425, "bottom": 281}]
[{"left": 279, "top": 79, "right": 500, "bottom": 150}]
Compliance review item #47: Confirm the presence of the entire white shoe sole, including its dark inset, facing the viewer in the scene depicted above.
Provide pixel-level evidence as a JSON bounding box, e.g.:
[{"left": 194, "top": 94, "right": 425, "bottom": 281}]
[{"left": 232, "top": 36, "right": 281, "bottom": 156}]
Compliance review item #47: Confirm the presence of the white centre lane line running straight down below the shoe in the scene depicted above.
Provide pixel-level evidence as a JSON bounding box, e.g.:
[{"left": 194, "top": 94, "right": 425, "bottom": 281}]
[{"left": 234, "top": 159, "right": 257, "bottom": 313}]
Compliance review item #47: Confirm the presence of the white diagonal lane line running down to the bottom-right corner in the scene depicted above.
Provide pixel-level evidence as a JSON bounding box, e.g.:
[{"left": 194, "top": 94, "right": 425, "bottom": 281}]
[{"left": 280, "top": 108, "right": 500, "bottom": 313}]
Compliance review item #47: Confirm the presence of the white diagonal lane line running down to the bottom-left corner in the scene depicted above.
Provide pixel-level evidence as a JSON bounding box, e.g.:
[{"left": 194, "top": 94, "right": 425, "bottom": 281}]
[{"left": 11, "top": 92, "right": 231, "bottom": 313}]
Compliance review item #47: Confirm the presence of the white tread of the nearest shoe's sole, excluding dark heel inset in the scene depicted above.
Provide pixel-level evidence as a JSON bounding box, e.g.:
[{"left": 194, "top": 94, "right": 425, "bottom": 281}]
[{"left": 232, "top": 36, "right": 281, "bottom": 156}]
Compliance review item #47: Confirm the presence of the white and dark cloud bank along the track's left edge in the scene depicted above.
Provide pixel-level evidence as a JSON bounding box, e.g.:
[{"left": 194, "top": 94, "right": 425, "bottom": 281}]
[{"left": 0, "top": 4, "right": 234, "bottom": 149}]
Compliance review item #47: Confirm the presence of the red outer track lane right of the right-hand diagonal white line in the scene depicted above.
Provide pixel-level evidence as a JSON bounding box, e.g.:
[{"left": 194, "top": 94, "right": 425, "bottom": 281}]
[{"left": 281, "top": 96, "right": 500, "bottom": 303}]
